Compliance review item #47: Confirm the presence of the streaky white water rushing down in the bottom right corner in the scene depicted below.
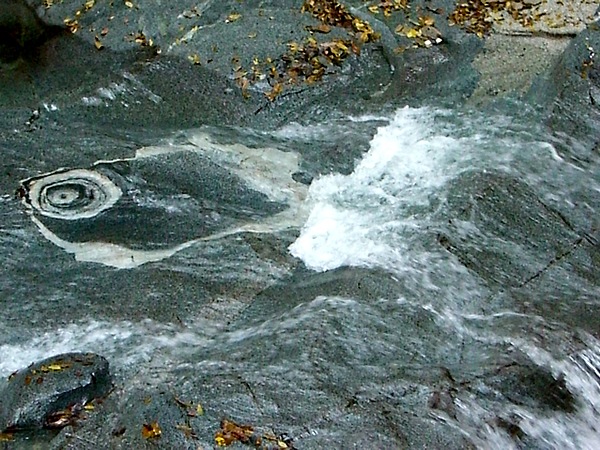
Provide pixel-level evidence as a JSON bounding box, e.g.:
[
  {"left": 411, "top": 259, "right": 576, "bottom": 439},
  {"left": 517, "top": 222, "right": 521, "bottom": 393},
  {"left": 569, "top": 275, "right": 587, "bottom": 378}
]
[{"left": 429, "top": 306, "right": 600, "bottom": 450}]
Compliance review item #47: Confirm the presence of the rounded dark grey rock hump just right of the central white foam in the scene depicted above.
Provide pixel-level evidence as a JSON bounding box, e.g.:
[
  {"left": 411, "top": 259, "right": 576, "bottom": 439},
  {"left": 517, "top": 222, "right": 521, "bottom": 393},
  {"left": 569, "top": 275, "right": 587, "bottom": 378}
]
[{"left": 438, "top": 172, "right": 580, "bottom": 286}]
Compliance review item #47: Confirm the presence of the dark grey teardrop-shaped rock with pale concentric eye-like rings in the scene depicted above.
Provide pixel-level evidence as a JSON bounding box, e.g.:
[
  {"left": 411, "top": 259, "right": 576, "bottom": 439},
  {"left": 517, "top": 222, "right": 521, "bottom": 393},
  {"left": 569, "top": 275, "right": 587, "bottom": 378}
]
[{"left": 23, "top": 151, "right": 285, "bottom": 249}]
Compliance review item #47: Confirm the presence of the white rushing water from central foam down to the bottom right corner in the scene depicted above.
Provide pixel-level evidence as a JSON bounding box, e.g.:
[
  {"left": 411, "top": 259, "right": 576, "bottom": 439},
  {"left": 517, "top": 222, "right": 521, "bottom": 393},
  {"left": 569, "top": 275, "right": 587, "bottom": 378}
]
[{"left": 290, "top": 108, "right": 600, "bottom": 450}]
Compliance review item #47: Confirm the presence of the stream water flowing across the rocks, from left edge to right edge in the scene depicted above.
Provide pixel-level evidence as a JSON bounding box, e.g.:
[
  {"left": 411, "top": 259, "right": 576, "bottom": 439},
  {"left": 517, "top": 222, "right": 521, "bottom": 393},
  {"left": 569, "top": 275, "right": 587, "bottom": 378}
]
[{"left": 0, "top": 105, "right": 600, "bottom": 449}]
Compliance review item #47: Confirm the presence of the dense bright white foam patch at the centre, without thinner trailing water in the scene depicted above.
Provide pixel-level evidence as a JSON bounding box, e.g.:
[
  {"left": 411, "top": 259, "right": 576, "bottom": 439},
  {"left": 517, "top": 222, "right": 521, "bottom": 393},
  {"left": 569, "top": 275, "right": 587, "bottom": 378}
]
[{"left": 290, "top": 108, "right": 464, "bottom": 271}]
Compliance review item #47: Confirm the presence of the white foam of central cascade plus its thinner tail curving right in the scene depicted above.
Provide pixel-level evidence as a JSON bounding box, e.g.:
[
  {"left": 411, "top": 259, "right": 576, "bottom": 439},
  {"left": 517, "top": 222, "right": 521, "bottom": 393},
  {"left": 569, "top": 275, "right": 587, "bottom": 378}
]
[{"left": 290, "top": 107, "right": 562, "bottom": 271}]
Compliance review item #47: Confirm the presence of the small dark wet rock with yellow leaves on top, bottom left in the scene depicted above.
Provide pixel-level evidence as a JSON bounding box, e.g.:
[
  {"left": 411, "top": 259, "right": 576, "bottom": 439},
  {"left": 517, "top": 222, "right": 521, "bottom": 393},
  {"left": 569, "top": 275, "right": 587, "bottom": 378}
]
[{"left": 0, "top": 353, "right": 112, "bottom": 430}]
